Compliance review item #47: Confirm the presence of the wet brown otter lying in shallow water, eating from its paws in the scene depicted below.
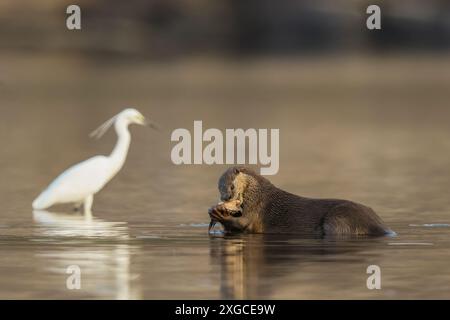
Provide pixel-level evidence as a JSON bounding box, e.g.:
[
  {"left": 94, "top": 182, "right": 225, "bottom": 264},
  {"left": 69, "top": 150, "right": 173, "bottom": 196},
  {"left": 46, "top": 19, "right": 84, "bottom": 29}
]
[{"left": 208, "top": 167, "right": 393, "bottom": 237}]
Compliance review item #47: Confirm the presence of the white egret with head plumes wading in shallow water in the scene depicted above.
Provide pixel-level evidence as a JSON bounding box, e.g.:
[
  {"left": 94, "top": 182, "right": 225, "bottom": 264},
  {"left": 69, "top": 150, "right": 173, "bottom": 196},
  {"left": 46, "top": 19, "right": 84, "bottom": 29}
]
[{"left": 33, "top": 108, "right": 153, "bottom": 214}]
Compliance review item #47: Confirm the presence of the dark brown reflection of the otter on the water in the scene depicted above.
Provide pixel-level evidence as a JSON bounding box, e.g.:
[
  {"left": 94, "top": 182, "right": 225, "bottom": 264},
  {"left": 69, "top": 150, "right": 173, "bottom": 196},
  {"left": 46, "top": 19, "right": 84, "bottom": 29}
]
[{"left": 210, "top": 234, "right": 374, "bottom": 299}]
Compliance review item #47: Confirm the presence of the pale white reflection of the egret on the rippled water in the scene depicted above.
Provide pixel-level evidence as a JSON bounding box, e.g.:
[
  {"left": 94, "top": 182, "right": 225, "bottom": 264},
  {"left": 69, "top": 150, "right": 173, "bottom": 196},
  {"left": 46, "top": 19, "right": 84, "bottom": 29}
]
[{"left": 33, "top": 210, "right": 141, "bottom": 299}]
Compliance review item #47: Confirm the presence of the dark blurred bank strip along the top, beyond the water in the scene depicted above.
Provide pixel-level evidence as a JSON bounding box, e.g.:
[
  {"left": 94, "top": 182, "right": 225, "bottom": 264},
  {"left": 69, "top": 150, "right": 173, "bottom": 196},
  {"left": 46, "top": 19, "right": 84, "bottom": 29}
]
[{"left": 0, "top": 0, "right": 450, "bottom": 60}]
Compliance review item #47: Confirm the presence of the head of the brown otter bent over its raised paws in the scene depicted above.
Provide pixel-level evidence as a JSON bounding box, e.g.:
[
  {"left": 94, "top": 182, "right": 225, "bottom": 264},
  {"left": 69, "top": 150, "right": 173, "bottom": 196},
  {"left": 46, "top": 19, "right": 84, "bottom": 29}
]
[{"left": 219, "top": 167, "right": 265, "bottom": 203}]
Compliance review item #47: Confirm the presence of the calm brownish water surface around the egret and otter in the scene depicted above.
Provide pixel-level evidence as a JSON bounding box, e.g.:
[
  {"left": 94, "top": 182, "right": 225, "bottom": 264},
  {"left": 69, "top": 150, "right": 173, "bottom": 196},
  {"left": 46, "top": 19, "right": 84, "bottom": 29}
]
[{"left": 0, "top": 56, "right": 450, "bottom": 299}]
